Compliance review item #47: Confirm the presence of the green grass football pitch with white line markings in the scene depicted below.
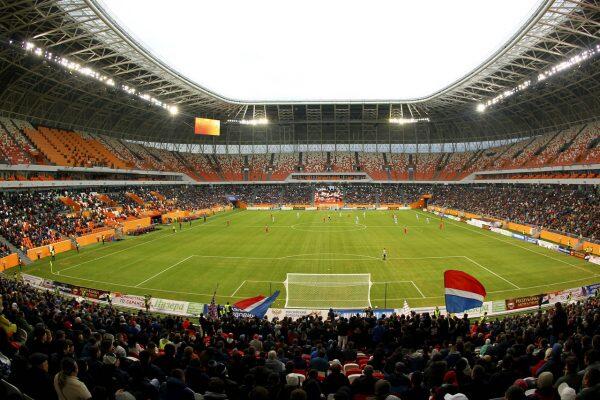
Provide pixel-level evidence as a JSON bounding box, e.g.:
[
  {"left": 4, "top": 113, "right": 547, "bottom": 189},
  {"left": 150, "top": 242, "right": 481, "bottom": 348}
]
[{"left": 18, "top": 211, "right": 599, "bottom": 307}]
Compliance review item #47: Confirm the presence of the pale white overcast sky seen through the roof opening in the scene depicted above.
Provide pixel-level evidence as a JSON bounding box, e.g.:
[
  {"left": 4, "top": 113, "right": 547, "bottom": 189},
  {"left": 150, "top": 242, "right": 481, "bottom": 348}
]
[{"left": 100, "top": 0, "right": 540, "bottom": 101}]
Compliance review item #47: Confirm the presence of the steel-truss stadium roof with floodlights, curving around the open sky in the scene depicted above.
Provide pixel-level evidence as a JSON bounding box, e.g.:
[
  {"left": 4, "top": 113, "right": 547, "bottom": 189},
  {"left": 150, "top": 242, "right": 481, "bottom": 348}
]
[{"left": 0, "top": 0, "right": 600, "bottom": 143}]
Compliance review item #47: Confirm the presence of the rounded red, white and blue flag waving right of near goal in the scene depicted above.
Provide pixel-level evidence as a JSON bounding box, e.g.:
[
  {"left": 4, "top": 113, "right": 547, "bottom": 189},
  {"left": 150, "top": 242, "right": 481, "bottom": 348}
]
[{"left": 444, "top": 270, "right": 486, "bottom": 313}]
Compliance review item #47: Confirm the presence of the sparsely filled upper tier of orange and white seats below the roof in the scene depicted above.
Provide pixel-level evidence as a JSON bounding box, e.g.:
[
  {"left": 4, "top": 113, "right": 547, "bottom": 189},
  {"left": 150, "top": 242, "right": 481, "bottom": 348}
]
[{"left": 0, "top": 118, "right": 600, "bottom": 182}]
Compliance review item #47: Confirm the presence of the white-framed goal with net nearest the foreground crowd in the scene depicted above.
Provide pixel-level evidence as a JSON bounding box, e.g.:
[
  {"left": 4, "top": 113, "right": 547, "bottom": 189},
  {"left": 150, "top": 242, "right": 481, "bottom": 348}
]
[{"left": 284, "top": 273, "right": 372, "bottom": 309}]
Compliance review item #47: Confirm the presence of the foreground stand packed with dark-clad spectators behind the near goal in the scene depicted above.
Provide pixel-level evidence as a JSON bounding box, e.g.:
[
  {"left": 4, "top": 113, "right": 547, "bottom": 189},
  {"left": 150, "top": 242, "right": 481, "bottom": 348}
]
[{"left": 0, "top": 277, "right": 600, "bottom": 400}]
